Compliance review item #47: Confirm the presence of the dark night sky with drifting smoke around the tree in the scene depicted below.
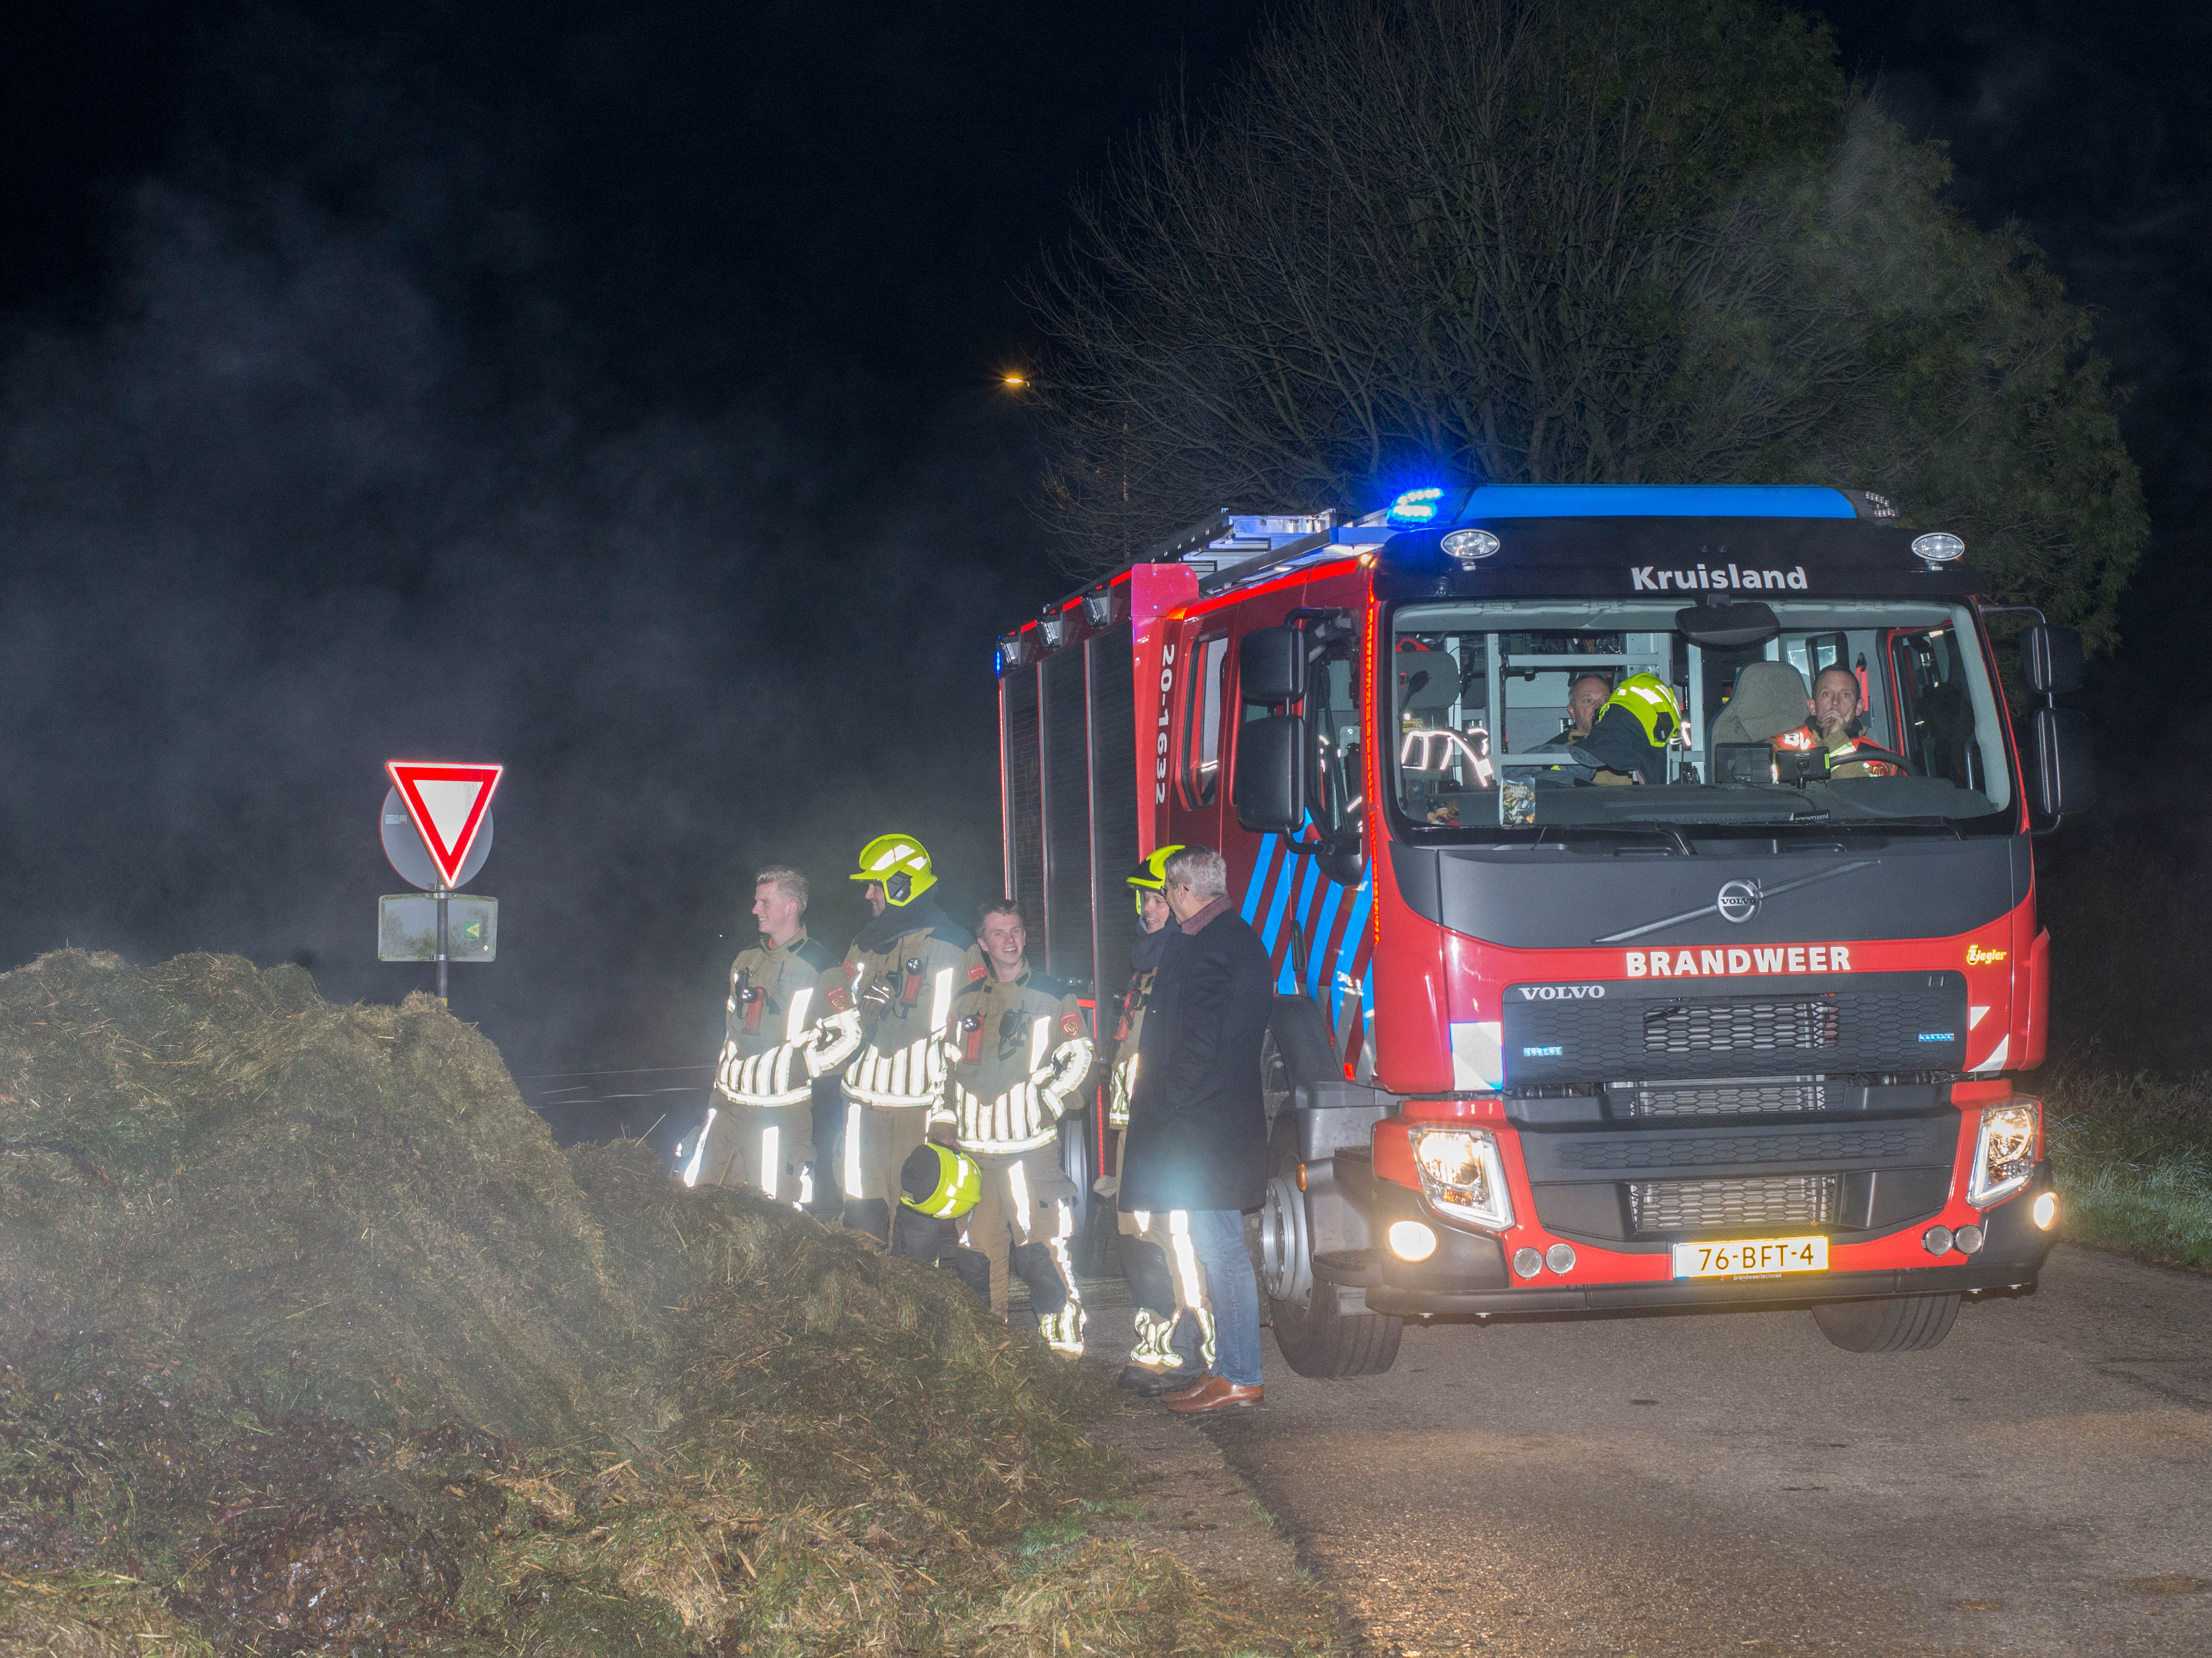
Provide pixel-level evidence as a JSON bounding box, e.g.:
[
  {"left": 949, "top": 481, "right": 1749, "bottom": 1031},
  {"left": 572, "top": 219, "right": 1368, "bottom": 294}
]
[{"left": 0, "top": 4, "right": 2212, "bottom": 1131}]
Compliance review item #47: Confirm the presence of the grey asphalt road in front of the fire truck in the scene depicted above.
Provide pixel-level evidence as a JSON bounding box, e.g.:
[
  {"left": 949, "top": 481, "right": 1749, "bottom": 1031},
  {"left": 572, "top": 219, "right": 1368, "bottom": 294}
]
[{"left": 1132, "top": 1247, "right": 2212, "bottom": 1658}]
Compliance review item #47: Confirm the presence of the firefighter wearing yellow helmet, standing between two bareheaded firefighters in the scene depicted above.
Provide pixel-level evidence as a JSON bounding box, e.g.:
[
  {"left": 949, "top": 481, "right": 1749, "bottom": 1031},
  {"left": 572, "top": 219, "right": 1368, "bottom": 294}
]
[{"left": 838, "top": 833, "right": 982, "bottom": 1260}]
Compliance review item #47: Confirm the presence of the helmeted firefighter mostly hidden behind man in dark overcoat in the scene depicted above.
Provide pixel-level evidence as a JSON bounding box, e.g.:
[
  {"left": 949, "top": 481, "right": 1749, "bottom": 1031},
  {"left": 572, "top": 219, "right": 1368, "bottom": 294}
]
[{"left": 1097, "top": 847, "right": 1214, "bottom": 1397}]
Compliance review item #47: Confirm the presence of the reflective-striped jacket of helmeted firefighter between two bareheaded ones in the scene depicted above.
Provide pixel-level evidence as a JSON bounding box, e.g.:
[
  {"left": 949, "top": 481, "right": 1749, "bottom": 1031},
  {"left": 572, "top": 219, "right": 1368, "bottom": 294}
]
[{"left": 845, "top": 898, "right": 982, "bottom": 1107}]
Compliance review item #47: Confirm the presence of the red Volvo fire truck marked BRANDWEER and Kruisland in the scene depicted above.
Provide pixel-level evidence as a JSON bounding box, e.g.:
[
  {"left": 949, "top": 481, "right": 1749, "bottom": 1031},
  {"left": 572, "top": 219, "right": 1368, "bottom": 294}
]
[{"left": 998, "top": 486, "right": 2092, "bottom": 1375}]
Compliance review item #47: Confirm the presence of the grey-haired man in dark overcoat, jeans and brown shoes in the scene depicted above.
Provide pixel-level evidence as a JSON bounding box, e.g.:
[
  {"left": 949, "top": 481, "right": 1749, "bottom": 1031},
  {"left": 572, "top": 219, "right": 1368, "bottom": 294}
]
[{"left": 1117, "top": 847, "right": 1274, "bottom": 1413}]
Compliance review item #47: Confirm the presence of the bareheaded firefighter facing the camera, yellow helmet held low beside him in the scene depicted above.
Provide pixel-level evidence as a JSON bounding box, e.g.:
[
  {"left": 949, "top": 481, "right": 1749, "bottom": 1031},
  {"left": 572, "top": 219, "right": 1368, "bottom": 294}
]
[{"left": 931, "top": 900, "right": 1093, "bottom": 1359}]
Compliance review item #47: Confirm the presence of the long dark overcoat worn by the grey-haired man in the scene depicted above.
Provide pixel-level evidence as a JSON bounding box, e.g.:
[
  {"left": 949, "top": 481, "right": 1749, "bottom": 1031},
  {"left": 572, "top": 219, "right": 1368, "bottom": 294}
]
[{"left": 1117, "top": 911, "right": 1274, "bottom": 1214}]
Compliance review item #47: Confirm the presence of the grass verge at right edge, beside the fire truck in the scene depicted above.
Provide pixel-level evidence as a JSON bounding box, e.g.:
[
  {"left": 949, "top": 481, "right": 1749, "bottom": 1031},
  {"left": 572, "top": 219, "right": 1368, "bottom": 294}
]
[{"left": 2033, "top": 1068, "right": 2212, "bottom": 1271}]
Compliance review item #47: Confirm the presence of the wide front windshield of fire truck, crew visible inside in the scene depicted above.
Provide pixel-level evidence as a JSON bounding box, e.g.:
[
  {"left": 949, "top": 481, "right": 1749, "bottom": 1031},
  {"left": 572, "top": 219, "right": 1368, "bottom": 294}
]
[{"left": 1385, "top": 599, "right": 2013, "bottom": 840}]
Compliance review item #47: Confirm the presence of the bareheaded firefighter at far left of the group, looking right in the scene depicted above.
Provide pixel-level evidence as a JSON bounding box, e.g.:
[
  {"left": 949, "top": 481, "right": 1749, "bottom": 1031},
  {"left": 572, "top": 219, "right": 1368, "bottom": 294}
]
[{"left": 686, "top": 865, "right": 850, "bottom": 1207}]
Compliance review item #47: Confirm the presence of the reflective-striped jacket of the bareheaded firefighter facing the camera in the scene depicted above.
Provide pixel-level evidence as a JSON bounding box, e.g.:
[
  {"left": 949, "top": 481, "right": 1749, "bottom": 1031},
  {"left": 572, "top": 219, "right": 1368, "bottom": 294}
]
[{"left": 929, "top": 966, "right": 1093, "bottom": 1154}]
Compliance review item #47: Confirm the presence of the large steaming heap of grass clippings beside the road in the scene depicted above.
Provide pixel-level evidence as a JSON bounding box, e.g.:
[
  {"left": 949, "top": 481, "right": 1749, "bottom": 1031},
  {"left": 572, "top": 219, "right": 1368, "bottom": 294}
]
[{"left": 0, "top": 951, "right": 1316, "bottom": 1658}]
